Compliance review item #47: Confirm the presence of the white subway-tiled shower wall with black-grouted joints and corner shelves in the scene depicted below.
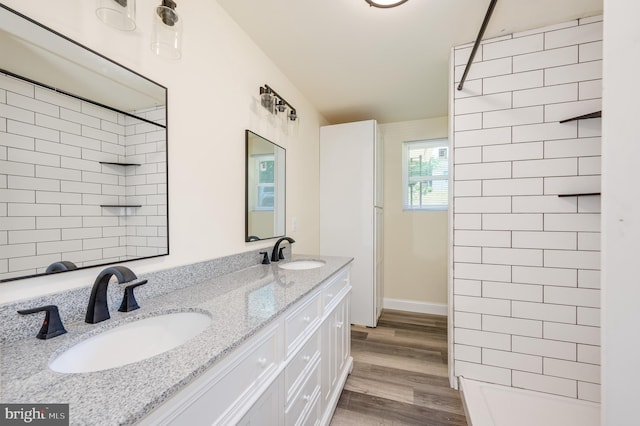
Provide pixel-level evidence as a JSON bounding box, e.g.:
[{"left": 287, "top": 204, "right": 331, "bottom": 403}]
[{"left": 453, "top": 17, "right": 602, "bottom": 401}]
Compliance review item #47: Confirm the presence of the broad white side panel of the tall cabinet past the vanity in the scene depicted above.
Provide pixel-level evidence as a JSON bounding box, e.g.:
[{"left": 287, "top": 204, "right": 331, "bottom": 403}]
[{"left": 320, "top": 120, "right": 376, "bottom": 327}]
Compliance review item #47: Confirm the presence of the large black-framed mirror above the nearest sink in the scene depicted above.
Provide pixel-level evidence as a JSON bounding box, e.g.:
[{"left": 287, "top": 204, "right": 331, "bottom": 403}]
[{"left": 0, "top": 4, "right": 169, "bottom": 282}]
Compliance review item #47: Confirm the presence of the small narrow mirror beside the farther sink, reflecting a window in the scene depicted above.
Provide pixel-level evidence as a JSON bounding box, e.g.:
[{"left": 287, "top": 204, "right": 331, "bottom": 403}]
[{"left": 245, "top": 130, "right": 286, "bottom": 242}]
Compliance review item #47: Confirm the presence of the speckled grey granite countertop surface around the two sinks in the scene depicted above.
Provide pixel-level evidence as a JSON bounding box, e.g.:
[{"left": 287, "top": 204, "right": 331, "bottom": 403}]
[{"left": 0, "top": 255, "right": 351, "bottom": 425}]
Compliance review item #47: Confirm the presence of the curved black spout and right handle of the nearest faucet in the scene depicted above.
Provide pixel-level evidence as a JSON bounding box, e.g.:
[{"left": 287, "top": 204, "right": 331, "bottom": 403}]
[{"left": 85, "top": 266, "right": 147, "bottom": 324}]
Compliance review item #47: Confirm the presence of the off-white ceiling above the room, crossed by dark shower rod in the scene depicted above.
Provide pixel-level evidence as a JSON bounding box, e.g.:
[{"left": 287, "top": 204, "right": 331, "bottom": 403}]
[{"left": 218, "top": 0, "right": 602, "bottom": 123}]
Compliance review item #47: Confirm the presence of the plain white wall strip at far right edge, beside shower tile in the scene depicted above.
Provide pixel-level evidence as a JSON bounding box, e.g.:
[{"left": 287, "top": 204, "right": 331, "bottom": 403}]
[{"left": 602, "top": 0, "right": 640, "bottom": 426}]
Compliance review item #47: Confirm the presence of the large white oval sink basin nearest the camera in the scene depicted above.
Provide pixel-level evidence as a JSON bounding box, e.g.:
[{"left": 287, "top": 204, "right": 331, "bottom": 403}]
[{"left": 49, "top": 312, "right": 211, "bottom": 373}]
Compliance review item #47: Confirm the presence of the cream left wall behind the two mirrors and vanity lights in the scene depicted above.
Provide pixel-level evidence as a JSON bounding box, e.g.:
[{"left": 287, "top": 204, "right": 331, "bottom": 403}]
[{"left": 0, "top": 0, "right": 325, "bottom": 302}]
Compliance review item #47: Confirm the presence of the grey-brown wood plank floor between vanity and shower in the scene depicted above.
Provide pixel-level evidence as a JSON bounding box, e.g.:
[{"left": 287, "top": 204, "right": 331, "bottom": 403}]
[{"left": 331, "top": 310, "right": 467, "bottom": 426}]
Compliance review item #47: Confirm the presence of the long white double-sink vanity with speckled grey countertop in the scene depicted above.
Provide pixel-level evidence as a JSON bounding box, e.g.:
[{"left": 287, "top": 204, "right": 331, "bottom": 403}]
[{"left": 1, "top": 255, "right": 352, "bottom": 425}]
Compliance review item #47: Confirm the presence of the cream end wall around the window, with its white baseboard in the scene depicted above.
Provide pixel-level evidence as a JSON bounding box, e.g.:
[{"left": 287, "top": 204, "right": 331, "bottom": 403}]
[{"left": 379, "top": 117, "right": 448, "bottom": 314}]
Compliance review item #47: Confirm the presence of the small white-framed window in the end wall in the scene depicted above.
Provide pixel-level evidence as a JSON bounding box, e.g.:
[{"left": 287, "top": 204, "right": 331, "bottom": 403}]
[{"left": 402, "top": 139, "right": 449, "bottom": 210}]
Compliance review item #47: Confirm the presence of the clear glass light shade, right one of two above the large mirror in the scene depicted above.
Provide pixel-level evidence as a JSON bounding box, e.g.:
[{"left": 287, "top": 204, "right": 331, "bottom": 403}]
[{"left": 151, "top": 6, "right": 182, "bottom": 59}]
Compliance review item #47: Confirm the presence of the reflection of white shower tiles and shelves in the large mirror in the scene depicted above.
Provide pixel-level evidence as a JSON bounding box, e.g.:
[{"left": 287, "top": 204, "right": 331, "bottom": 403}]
[{"left": 0, "top": 74, "right": 167, "bottom": 279}]
